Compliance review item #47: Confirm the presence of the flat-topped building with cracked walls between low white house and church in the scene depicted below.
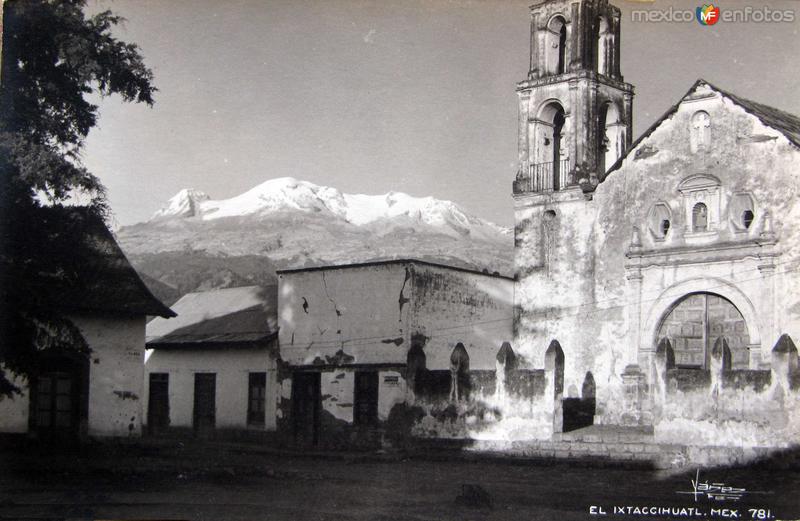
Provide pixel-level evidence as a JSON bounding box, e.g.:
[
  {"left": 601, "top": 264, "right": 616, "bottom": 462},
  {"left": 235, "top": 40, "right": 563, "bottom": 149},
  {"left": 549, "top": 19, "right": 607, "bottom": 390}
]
[{"left": 277, "top": 259, "right": 513, "bottom": 446}]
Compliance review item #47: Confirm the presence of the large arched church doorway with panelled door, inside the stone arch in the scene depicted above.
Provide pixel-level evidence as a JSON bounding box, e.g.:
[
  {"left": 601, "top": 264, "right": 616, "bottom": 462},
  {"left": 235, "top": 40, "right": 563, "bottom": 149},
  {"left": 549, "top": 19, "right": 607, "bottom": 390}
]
[{"left": 656, "top": 292, "right": 750, "bottom": 370}]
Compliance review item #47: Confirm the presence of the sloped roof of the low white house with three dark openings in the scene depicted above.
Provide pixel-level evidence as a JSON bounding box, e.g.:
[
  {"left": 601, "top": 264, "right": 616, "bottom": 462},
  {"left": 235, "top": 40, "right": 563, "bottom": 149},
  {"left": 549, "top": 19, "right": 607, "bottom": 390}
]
[{"left": 147, "top": 286, "right": 278, "bottom": 349}]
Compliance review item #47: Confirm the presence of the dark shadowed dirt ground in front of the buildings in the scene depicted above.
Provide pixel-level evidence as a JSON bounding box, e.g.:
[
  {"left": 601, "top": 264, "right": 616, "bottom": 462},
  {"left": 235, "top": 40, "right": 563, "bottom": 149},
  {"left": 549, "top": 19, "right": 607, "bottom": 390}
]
[{"left": 0, "top": 441, "right": 800, "bottom": 521}]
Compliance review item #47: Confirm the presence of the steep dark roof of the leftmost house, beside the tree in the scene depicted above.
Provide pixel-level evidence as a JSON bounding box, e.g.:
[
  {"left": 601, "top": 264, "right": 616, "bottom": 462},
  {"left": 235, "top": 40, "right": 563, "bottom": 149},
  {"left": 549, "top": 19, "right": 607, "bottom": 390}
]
[{"left": 36, "top": 207, "right": 175, "bottom": 317}]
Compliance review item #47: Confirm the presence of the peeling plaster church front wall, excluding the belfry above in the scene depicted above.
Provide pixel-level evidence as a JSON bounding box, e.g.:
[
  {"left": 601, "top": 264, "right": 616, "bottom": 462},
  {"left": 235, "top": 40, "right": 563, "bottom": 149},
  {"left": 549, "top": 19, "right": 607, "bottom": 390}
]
[{"left": 513, "top": 84, "right": 800, "bottom": 439}]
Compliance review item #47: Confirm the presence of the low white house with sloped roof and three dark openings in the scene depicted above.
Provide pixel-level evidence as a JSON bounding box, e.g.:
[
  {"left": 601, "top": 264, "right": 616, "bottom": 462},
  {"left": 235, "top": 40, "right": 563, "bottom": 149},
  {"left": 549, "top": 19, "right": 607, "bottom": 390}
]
[{"left": 144, "top": 286, "right": 278, "bottom": 439}]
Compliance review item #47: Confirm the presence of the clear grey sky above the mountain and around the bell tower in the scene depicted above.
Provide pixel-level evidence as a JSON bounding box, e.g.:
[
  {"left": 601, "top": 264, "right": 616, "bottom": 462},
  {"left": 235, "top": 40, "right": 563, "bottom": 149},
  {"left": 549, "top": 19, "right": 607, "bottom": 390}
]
[{"left": 83, "top": 0, "right": 800, "bottom": 226}]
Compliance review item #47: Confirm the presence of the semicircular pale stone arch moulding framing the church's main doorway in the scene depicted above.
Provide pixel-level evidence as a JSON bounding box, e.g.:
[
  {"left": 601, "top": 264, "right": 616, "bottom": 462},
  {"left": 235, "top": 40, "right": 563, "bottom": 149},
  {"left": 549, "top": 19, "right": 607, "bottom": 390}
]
[{"left": 640, "top": 277, "right": 763, "bottom": 370}]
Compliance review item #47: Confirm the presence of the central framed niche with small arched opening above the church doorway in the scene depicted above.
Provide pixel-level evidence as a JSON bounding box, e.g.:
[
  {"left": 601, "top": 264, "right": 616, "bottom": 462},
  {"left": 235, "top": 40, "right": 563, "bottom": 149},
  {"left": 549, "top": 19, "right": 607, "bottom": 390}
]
[{"left": 678, "top": 174, "right": 721, "bottom": 241}]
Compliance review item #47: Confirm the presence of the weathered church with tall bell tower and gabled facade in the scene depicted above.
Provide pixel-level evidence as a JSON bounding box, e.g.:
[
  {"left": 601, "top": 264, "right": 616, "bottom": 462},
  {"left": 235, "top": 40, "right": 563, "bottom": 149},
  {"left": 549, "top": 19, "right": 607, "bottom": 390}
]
[{"left": 513, "top": 0, "right": 800, "bottom": 445}]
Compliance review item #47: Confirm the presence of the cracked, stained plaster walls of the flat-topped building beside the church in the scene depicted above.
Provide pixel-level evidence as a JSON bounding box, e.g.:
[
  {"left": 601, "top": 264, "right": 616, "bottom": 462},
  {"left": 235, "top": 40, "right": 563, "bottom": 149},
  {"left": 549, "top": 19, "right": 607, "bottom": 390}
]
[{"left": 279, "top": 262, "right": 513, "bottom": 439}]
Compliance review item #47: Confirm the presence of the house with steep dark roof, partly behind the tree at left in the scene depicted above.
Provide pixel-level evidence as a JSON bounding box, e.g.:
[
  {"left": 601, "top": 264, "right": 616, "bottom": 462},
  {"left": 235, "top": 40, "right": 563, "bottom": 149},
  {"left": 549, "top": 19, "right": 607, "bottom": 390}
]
[{"left": 0, "top": 207, "right": 175, "bottom": 437}]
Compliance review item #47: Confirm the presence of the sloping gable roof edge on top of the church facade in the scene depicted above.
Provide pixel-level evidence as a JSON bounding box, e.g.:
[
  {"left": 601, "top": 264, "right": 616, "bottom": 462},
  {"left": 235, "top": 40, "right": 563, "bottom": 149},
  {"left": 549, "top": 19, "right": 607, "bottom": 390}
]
[{"left": 605, "top": 78, "right": 800, "bottom": 176}]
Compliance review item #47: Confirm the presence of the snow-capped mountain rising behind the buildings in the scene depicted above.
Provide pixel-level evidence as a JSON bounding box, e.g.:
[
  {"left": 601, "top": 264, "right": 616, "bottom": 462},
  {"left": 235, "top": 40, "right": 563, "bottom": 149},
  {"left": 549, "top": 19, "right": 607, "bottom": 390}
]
[{"left": 117, "top": 177, "right": 513, "bottom": 289}]
